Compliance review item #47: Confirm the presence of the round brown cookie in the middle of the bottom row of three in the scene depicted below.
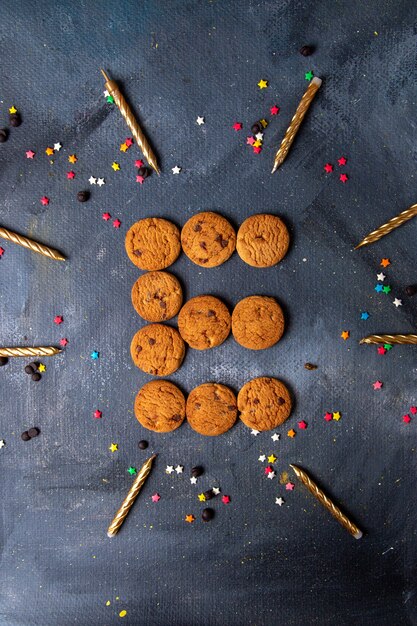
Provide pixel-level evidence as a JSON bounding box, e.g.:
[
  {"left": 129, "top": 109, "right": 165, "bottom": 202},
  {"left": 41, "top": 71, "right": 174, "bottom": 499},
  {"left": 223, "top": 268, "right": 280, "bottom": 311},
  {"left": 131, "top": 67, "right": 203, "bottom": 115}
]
[{"left": 185, "top": 383, "right": 237, "bottom": 436}]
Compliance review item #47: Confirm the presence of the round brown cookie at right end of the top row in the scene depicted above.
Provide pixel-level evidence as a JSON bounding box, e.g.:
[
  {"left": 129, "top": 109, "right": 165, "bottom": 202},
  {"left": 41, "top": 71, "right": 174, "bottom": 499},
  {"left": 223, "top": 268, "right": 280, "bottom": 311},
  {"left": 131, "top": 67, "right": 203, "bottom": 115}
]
[{"left": 236, "top": 213, "right": 290, "bottom": 267}]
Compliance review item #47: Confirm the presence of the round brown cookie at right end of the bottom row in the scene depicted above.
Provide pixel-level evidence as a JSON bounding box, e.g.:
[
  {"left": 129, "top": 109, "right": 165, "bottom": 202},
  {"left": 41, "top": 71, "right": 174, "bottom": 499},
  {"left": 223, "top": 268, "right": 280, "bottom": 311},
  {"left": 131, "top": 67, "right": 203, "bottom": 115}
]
[{"left": 237, "top": 376, "right": 292, "bottom": 431}]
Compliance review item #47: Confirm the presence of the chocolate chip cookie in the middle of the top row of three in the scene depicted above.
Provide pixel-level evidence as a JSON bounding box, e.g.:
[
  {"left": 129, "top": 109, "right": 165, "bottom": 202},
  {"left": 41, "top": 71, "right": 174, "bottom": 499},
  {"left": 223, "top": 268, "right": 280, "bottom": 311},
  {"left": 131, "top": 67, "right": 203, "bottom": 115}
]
[{"left": 181, "top": 211, "right": 236, "bottom": 267}]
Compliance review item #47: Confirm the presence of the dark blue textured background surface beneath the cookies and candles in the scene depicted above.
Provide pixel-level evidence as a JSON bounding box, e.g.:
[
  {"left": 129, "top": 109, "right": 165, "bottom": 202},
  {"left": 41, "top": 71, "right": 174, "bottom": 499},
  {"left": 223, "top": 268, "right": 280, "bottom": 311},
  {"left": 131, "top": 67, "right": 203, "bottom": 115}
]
[{"left": 0, "top": 0, "right": 417, "bottom": 626}]
